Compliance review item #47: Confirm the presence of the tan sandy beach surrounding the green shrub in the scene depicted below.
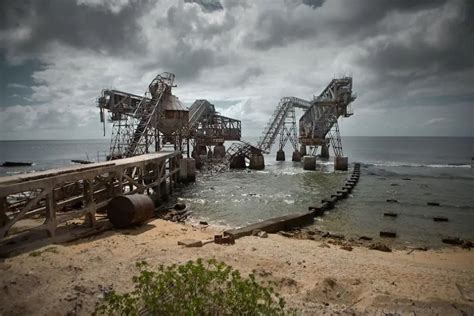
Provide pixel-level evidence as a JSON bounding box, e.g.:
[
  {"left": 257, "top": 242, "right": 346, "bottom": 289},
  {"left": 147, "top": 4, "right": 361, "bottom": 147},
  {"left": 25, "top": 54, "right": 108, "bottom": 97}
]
[{"left": 0, "top": 220, "right": 474, "bottom": 315}]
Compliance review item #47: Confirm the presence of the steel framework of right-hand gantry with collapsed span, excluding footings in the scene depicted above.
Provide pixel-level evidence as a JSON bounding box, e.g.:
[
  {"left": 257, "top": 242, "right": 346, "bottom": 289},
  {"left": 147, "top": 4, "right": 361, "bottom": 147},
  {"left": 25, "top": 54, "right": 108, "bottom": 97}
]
[{"left": 227, "top": 77, "right": 356, "bottom": 160}]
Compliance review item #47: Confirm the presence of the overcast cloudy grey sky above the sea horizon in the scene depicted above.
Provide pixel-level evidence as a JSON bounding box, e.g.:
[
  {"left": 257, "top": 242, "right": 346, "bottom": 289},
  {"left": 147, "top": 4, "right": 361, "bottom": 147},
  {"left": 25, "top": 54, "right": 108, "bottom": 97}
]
[{"left": 0, "top": 0, "right": 474, "bottom": 140}]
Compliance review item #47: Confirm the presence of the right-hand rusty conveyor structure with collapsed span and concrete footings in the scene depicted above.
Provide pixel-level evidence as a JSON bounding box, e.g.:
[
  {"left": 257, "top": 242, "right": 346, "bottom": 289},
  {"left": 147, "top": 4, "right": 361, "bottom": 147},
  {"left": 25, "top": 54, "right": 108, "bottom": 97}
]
[{"left": 227, "top": 77, "right": 356, "bottom": 170}]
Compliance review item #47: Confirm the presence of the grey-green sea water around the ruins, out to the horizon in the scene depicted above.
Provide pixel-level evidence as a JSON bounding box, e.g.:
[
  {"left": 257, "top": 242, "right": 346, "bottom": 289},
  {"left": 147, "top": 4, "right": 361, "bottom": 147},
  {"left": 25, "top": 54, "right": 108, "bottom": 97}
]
[{"left": 0, "top": 137, "right": 474, "bottom": 247}]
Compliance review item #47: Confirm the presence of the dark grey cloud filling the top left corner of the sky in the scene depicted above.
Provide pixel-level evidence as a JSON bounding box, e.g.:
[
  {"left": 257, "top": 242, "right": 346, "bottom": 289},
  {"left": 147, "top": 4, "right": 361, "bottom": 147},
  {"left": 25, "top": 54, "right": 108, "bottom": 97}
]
[{"left": 0, "top": 0, "right": 151, "bottom": 59}]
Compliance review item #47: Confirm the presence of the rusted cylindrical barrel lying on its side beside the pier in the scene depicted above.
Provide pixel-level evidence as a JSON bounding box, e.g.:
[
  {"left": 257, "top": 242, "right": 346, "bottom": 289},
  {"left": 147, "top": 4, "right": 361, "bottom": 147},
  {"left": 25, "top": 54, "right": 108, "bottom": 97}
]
[{"left": 107, "top": 194, "right": 155, "bottom": 228}]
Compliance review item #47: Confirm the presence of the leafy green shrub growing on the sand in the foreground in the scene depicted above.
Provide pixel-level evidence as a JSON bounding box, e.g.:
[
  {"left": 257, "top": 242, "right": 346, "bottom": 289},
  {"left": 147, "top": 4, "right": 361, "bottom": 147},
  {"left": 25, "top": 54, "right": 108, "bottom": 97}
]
[{"left": 96, "top": 259, "right": 286, "bottom": 315}]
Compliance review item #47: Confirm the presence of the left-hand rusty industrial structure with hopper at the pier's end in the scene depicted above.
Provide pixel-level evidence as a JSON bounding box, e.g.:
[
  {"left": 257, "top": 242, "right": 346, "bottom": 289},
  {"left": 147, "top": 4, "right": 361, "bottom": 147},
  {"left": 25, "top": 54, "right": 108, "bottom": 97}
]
[{"left": 98, "top": 72, "right": 241, "bottom": 160}]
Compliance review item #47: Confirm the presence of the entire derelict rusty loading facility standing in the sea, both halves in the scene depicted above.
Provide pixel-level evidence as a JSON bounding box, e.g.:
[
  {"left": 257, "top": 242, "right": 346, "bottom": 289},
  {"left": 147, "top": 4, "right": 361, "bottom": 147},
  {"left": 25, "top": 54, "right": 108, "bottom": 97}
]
[{"left": 99, "top": 72, "right": 356, "bottom": 170}]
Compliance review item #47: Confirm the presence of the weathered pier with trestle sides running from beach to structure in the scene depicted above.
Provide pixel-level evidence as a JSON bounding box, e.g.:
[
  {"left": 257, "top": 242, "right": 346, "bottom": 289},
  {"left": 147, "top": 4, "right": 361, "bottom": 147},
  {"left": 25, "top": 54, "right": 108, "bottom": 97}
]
[{"left": 0, "top": 151, "right": 189, "bottom": 243}]
